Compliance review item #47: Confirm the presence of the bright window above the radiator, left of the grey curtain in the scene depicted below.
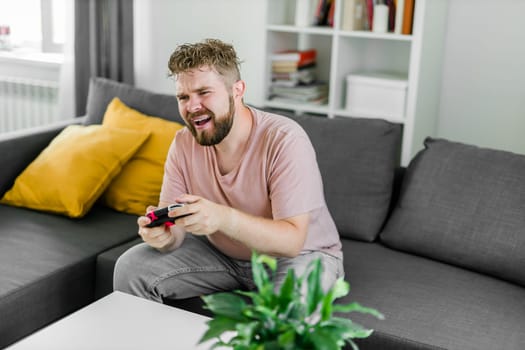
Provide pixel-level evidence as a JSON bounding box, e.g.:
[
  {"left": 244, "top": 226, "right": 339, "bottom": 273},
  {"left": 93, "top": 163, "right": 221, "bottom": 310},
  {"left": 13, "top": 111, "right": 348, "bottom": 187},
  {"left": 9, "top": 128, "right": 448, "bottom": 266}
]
[{"left": 0, "top": 0, "right": 66, "bottom": 52}]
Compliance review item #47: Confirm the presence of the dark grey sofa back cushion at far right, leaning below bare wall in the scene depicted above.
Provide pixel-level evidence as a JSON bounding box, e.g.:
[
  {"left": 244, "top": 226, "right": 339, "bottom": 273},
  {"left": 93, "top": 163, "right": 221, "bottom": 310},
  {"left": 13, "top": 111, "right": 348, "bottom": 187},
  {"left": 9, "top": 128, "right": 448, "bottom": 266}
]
[{"left": 381, "top": 138, "right": 525, "bottom": 285}]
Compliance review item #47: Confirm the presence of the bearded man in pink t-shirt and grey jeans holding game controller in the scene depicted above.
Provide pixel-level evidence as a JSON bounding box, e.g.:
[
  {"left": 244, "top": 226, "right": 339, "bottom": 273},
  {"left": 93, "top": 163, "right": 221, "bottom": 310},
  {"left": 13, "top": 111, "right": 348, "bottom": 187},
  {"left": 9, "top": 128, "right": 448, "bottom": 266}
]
[{"left": 114, "top": 39, "right": 343, "bottom": 302}]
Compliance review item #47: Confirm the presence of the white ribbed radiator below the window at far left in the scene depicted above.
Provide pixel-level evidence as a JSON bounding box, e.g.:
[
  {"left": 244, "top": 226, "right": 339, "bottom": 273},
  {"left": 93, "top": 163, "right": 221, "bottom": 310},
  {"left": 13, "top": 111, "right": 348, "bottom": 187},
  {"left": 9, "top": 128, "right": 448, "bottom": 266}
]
[{"left": 0, "top": 76, "right": 60, "bottom": 132}]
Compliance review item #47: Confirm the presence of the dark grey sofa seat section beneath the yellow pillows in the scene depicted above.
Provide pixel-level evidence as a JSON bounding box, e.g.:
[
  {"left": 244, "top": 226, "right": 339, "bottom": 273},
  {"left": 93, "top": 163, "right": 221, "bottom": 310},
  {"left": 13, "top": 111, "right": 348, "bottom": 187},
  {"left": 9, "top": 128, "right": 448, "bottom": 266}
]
[{"left": 0, "top": 205, "right": 137, "bottom": 348}]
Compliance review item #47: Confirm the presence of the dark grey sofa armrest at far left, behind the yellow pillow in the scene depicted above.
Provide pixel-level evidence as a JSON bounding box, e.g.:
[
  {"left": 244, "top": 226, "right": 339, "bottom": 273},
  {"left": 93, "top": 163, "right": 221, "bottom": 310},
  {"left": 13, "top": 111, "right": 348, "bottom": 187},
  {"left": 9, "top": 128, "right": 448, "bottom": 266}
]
[{"left": 0, "top": 117, "right": 85, "bottom": 197}]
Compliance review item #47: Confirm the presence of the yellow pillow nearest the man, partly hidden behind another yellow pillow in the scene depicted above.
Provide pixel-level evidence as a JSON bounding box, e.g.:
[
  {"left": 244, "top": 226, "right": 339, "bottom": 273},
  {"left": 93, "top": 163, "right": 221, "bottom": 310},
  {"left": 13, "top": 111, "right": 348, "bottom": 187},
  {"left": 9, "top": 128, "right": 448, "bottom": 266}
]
[{"left": 102, "top": 97, "right": 184, "bottom": 215}]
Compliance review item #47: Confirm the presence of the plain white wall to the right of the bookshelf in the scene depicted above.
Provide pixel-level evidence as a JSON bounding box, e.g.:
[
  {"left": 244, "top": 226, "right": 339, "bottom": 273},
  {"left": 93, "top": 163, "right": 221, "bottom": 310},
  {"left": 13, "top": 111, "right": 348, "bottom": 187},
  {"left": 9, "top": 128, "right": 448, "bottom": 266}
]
[{"left": 438, "top": 0, "right": 525, "bottom": 154}]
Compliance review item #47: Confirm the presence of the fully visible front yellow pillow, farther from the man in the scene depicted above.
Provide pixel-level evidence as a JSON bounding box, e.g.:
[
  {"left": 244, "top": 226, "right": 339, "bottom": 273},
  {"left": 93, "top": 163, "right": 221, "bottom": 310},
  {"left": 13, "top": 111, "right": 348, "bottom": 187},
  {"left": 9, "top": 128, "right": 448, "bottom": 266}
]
[{"left": 0, "top": 125, "right": 149, "bottom": 218}]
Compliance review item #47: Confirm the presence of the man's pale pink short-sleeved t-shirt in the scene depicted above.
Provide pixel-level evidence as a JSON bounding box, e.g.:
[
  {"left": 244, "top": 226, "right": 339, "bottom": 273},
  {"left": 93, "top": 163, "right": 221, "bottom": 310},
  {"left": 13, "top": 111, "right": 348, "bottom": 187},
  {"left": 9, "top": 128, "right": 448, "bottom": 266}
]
[{"left": 160, "top": 108, "right": 342, "bottom": 257}]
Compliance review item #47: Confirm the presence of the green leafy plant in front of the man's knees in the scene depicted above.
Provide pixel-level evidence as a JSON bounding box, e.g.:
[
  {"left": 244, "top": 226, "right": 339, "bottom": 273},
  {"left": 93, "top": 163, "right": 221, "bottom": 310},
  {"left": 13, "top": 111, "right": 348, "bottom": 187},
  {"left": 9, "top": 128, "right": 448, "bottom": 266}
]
[{"left": 200, "top": 253, "right": 383, "bottom": 350}]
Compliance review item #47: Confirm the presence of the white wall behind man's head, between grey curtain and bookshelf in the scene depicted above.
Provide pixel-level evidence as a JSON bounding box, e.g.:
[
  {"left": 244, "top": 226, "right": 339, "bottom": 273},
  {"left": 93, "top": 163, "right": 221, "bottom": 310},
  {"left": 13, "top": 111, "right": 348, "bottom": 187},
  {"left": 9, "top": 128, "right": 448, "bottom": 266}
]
[{"left": 134, "top": 0, "right": 266, "bottom": 106}]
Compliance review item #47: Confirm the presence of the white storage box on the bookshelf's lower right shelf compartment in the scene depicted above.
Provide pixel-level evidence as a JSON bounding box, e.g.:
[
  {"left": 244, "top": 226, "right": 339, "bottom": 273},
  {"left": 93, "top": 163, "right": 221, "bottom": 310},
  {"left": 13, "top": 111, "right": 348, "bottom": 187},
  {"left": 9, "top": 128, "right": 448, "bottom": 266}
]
[{"left": 346, "top": 73, "right": 408, "bottom": 119}]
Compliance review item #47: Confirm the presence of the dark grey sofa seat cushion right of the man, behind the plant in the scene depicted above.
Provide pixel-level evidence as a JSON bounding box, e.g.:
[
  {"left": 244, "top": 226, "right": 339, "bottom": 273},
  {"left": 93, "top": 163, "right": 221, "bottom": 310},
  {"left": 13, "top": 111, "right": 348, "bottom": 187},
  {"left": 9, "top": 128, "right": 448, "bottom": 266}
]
[{"left": 337, "top": 240, "right": 525, "bottom": 350}]
